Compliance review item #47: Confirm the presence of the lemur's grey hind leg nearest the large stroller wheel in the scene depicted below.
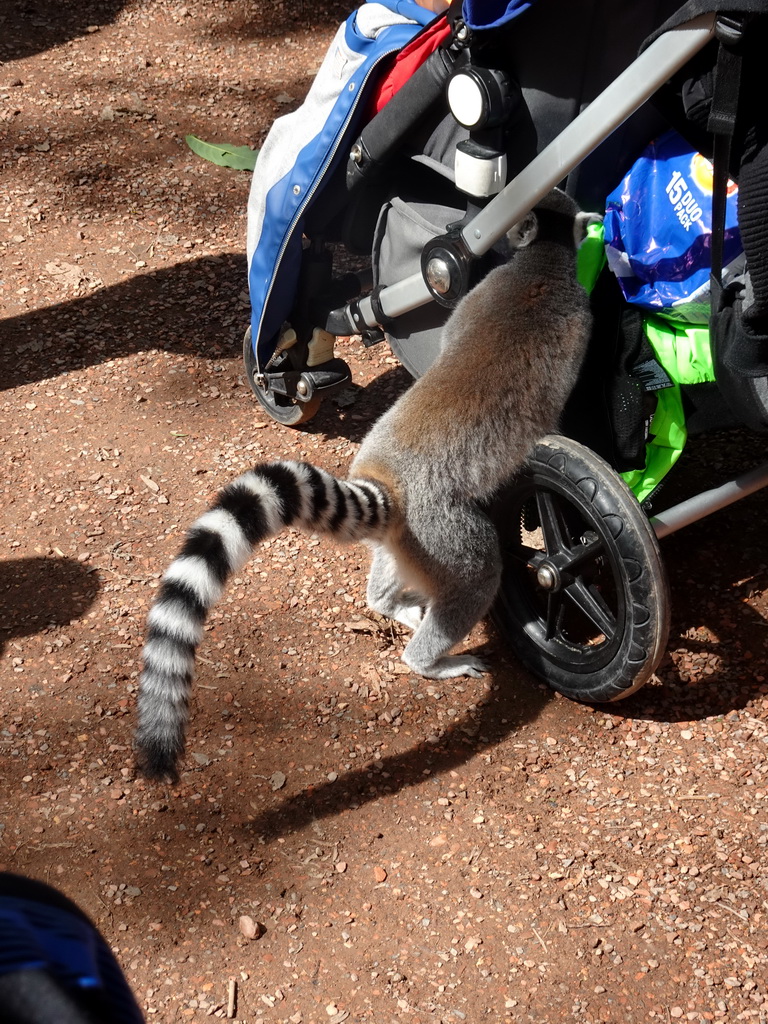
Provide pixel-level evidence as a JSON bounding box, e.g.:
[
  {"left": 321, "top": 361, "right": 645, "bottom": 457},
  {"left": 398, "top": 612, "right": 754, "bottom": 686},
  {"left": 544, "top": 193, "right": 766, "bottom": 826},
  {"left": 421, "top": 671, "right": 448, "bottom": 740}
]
[{"left": 402, "top": 507, "right": 502, "bottom": 679}]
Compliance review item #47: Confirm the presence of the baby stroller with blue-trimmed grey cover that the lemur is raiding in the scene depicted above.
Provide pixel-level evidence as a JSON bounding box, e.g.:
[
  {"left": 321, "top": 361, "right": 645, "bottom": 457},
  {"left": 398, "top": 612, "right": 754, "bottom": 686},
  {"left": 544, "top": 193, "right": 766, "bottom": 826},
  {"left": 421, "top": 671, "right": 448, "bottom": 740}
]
[{"left": 244, "top": 0, "right": 768, "bottom": 701}]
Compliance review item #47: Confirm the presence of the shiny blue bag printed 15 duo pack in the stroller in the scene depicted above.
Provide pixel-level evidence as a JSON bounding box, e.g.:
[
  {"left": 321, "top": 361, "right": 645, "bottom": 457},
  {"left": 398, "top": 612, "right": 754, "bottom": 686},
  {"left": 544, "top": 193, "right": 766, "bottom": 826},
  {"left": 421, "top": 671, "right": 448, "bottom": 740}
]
[{"left": 605, "top": 131, "right": 744, "bottom": 324}]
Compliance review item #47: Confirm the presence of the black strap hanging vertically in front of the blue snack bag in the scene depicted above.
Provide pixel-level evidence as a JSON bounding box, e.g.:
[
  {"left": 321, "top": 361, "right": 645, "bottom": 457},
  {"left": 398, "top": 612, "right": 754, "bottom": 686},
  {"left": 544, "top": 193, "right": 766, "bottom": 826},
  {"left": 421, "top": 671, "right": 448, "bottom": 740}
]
[{"left": 707, "top": 14, "right": 744, "bottom": 301}]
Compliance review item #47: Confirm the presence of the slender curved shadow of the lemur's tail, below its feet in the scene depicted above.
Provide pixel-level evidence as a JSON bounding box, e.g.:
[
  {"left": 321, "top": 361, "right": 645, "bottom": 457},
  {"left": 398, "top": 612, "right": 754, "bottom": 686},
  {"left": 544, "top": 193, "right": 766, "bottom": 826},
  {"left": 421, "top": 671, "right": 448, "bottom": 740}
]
[{"left": 241, "top": 630, "right": 555, "bottom": 842}]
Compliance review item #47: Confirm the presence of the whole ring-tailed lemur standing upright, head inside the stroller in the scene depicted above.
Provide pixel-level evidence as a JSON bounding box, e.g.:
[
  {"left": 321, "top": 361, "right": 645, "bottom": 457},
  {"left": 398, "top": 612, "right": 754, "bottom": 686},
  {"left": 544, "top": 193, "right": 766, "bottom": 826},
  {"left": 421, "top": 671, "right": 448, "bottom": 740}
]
[{"left": 136, "top": 190, "right": 591, "bottom": 779}]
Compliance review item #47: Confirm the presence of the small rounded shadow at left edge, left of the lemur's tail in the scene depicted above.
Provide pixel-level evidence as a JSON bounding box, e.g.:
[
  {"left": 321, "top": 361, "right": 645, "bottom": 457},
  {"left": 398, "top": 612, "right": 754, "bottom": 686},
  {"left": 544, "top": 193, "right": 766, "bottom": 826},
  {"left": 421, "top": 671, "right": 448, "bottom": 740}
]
[{"left": 0, "top": 557, "right": 99, "bottom": 653}]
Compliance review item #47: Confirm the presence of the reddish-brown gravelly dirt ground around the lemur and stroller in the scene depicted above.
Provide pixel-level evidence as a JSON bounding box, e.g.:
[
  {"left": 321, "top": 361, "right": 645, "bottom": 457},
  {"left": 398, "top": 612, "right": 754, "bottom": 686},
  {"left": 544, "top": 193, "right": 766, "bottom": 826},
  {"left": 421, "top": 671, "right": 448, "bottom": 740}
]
[{"left": 0, "top": 0, "right": 768, "bottom": 1024}]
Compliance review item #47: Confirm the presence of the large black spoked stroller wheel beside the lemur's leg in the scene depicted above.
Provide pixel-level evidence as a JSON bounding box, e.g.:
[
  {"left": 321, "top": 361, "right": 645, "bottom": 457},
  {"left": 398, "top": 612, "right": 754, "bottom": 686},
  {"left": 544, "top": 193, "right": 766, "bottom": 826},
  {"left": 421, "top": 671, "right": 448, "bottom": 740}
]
[{"left": 492, "top": 436, "right": 669, "bottom": 702}]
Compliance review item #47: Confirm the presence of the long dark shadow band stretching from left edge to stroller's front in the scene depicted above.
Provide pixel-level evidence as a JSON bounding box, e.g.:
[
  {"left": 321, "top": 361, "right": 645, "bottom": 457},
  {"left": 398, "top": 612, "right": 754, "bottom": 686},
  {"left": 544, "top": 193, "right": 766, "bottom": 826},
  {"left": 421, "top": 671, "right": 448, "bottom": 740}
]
[{"left": 0, "top": 254, "right": 248, "bottom": 390}]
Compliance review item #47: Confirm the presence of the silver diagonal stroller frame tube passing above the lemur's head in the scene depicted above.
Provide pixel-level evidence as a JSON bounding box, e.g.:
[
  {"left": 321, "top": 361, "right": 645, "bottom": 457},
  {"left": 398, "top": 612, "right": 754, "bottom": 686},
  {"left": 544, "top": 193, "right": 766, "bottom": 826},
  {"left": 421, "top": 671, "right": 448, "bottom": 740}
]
[{"left": 347, "top": 13, "right": 717, "bottom": 330}]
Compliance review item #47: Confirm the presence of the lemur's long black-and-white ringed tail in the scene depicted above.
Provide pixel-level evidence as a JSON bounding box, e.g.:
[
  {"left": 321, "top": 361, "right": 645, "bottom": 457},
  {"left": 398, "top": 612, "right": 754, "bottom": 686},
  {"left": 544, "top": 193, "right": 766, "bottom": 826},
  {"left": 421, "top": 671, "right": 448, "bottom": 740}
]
[{"left": 136, "top": 462, "right": 391, "bottom": 779}]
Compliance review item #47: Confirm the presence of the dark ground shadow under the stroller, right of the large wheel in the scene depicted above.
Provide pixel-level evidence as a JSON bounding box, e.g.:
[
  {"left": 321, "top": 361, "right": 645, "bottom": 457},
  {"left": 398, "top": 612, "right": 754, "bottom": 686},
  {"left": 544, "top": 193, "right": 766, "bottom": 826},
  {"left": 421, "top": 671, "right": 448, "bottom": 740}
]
[{"left": 610, "top": 430, "right": 768, "bottom": 722}]
